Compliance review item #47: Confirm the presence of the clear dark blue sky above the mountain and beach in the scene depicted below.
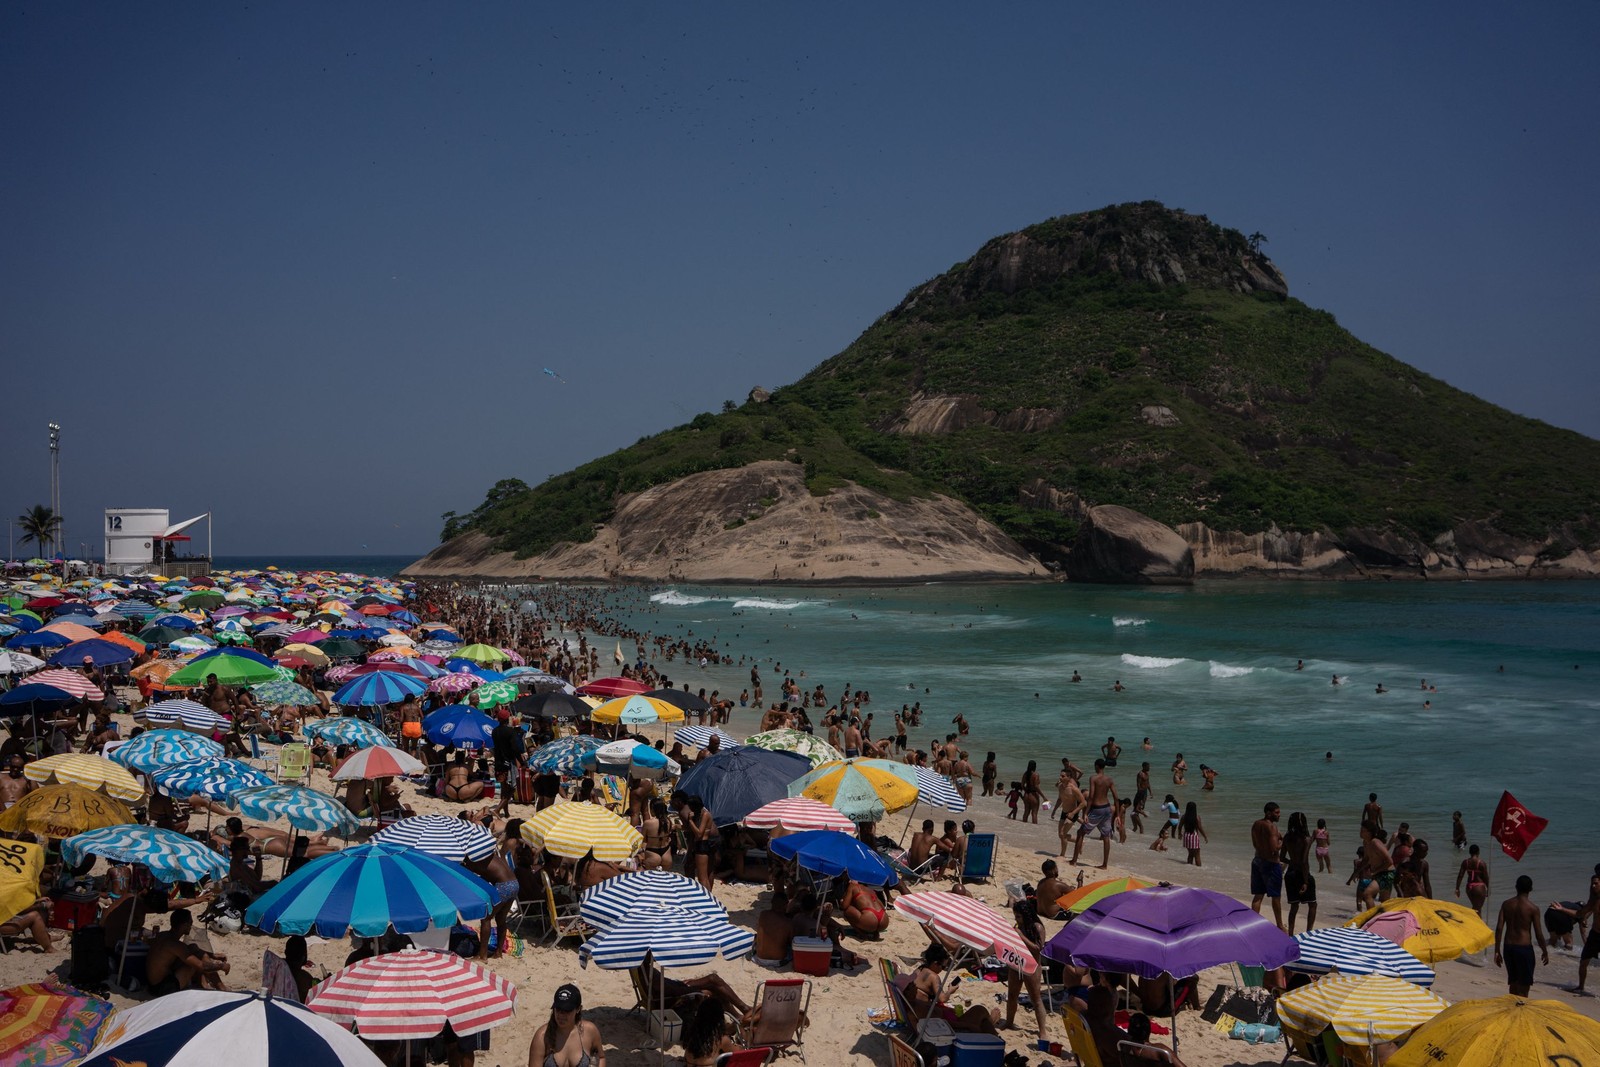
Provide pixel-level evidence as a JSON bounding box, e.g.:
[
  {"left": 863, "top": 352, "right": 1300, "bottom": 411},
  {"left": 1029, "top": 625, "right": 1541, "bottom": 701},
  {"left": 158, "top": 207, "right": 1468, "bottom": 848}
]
[{"left": 0, "top": 2, "right": 1600, "bottom": 553}]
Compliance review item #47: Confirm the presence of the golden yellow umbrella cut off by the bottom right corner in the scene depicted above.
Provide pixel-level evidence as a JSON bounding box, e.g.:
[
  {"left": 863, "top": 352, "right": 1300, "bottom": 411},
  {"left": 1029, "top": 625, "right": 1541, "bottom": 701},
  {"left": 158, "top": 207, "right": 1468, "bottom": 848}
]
[{"left": 1389, "top": 995, "right": 1600, "bottom": 1067}]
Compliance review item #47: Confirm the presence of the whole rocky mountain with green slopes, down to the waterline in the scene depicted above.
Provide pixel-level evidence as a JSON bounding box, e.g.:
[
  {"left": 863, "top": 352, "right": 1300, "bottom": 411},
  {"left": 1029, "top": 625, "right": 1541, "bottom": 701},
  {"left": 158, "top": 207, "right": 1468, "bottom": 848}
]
[{"left": 408, "top": 202, "right": 1600, "bottom": 582}]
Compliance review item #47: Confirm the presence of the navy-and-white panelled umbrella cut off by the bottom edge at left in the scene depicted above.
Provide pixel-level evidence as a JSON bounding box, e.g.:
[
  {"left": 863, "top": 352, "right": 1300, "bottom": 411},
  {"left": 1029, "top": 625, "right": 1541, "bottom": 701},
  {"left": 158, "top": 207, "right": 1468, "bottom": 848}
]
[{"left": 77, "top": 989, "right": 384, "bottom": 1067}]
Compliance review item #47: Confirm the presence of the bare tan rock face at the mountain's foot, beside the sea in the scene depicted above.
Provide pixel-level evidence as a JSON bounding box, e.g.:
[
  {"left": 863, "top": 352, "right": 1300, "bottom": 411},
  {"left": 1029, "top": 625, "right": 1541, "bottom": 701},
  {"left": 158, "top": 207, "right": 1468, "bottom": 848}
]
[{"left": 405, "top": 461, "right": 1046, "bottom": 582}]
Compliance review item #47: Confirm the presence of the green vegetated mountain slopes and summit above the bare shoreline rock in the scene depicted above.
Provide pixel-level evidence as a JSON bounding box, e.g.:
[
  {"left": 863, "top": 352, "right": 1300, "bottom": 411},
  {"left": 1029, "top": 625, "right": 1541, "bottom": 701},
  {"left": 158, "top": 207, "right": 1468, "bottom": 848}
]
[{"left": 445, "top": 203, "right": 1600, "bottom": 558}]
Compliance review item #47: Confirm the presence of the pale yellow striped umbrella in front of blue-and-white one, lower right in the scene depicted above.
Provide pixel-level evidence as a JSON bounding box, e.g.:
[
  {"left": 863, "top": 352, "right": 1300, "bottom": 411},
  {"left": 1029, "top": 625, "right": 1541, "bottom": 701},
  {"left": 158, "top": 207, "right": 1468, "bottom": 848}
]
[{"left": 1278, "top": 974, "right": 1452, "bottom": 1062}]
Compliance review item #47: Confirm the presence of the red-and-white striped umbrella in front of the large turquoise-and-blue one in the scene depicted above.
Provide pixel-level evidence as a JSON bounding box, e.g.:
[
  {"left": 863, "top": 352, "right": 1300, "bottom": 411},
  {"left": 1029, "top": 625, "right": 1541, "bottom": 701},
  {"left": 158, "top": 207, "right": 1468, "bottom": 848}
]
[{"left": 306, "top": 949, "right": 517, "bottom": 1041}]
